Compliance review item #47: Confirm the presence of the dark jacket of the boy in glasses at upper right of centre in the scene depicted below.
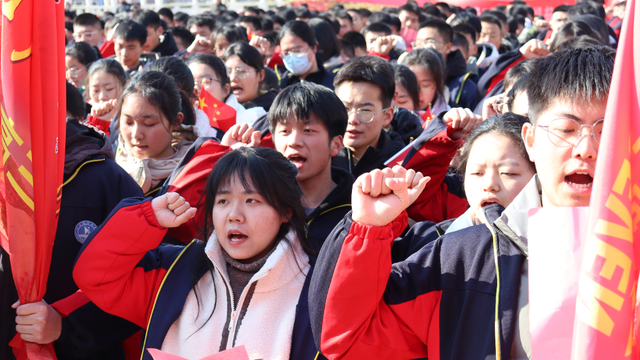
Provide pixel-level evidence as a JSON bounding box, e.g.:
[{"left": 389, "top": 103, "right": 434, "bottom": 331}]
[{"left": 447, "top": 50, "right": 478, "bottom": 109}]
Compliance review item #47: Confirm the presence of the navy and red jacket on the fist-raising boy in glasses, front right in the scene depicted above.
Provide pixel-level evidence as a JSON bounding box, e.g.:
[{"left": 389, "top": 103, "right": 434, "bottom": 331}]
[{"left": 309, "top": 205, "right": 527, "bottom": 360}]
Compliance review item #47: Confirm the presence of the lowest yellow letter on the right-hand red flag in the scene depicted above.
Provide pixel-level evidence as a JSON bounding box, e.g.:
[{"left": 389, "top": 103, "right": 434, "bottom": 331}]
[{"left": 576, "top": 275, "right": 624, "bottom": 336}]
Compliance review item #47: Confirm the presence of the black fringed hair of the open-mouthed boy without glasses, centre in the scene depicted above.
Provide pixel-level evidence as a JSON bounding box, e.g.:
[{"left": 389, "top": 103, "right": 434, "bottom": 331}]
[{"left": 267, "top": 81, "right": 349, "bottom": 141}]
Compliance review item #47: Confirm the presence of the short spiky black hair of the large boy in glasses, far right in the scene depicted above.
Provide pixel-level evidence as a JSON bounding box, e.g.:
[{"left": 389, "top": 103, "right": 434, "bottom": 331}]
[{"left": 527, "top": 46, "right": 616, "bottom": 123}]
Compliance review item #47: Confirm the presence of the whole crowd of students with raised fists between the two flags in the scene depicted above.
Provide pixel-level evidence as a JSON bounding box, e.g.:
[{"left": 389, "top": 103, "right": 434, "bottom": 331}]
[{"left": 0, "top": 0, "right": 625, "bottom": 360}]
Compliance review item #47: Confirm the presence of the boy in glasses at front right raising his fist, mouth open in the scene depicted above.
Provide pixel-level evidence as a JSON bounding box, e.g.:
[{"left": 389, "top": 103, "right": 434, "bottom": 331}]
[{"left": 309, "top": 46, "right": 615, "bottom": 359}]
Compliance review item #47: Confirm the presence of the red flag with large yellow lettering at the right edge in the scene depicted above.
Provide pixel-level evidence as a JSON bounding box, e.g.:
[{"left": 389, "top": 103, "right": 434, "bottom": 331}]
[{"left": 572, "top": 0, "right": 640, "bottom": 359}]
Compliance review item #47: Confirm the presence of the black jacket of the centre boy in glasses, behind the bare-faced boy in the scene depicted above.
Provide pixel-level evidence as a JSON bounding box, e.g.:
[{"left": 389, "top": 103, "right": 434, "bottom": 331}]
[{"left": 331, "top": 130, "right": 405, "bottom": 178}]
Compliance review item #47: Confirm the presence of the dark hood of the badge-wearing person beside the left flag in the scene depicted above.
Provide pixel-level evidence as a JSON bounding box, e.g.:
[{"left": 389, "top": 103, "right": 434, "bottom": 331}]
[{"left": 64, "top": 118, "right": 113, "bottom": 180}]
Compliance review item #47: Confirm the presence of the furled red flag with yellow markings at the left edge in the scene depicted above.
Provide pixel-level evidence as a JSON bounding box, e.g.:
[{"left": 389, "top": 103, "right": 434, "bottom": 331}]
[{"left": 0, "top": 0, "right": 66, "bottom": 359}]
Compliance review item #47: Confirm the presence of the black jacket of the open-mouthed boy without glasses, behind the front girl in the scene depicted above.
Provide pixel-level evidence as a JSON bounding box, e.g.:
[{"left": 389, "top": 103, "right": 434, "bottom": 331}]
[{"left": 307, "top": 167, "right": 355, "bottom": 251}]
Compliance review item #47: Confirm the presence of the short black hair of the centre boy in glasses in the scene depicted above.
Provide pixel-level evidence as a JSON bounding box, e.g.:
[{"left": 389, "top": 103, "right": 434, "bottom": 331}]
[{"left": 333, "top": 56, "right": 396, "bottom": 108}]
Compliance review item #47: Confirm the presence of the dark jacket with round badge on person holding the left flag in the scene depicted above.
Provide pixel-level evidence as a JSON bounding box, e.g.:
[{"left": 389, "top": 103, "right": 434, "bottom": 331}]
[{"left": 0, "top": 118, "right": 142, "bottom": 359}]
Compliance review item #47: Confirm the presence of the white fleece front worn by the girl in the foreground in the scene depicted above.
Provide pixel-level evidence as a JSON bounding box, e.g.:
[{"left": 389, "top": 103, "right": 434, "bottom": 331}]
[{"left": 162, "top": 233, "right": 309, "bottom": 360}]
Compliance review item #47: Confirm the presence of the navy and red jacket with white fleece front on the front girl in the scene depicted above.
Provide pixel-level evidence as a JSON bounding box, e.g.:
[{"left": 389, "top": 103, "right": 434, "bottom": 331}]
[{"left": 74, "top": 198, "right": 324, "bottom": 360}]
